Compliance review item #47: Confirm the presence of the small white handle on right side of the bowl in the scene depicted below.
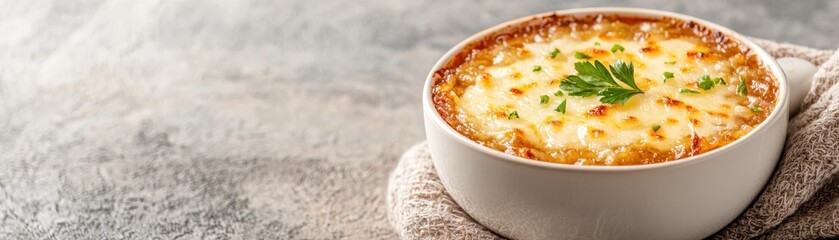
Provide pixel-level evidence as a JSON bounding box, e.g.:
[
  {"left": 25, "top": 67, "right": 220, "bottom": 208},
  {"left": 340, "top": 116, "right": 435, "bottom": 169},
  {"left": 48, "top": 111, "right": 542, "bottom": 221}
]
[{"left": 776, "top": 57, "right": 818, "bottom": 116}]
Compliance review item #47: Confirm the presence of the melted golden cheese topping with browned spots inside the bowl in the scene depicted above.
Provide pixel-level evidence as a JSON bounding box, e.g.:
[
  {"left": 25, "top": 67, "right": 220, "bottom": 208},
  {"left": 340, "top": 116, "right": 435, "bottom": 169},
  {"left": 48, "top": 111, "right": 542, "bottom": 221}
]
[{"left": 435, "top": 14, "right": 777, "bottom": 165}]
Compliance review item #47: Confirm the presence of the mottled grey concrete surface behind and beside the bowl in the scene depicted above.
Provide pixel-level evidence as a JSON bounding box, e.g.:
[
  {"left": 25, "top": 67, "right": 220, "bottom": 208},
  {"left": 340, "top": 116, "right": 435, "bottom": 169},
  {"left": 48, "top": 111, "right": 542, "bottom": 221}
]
[{"left": 0, "top": 0, "right": 839, "bottom": 239}]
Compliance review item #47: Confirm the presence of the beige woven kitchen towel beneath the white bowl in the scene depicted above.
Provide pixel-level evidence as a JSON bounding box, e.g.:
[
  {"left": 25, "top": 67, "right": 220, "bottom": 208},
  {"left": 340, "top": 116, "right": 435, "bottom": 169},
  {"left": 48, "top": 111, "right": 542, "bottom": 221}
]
[{"left": 387, "top": 39, "right": 839, "bottom": 239}]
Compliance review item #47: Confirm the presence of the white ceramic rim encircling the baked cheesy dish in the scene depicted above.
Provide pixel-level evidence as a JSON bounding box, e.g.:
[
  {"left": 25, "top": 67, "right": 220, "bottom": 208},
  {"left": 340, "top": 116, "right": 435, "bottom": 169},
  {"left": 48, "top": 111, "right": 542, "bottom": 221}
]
[{"left": 422, "top": 7, "right": 789, "bottom": 172}]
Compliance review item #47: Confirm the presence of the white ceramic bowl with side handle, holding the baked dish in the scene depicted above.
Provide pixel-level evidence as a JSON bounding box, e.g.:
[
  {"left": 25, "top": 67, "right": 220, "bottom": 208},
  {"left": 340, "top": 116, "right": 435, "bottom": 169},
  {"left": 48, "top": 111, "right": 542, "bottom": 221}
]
[{"left": 423, "top": 8, "right": 815, "bottom": 239}]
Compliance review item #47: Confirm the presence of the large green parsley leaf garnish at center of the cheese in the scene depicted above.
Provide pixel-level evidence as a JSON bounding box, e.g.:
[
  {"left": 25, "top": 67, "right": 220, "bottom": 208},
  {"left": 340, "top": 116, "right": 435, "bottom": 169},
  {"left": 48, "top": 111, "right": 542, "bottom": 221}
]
[{"left": 559, "top": 60, "right": 644, "bottom": 104}]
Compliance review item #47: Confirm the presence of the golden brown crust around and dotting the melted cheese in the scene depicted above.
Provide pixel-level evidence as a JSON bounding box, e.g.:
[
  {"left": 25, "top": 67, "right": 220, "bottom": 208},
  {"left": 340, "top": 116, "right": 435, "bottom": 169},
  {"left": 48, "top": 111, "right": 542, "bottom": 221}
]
[{"left": 432, "top": 15, "right": 778, "bottom": 165}]
